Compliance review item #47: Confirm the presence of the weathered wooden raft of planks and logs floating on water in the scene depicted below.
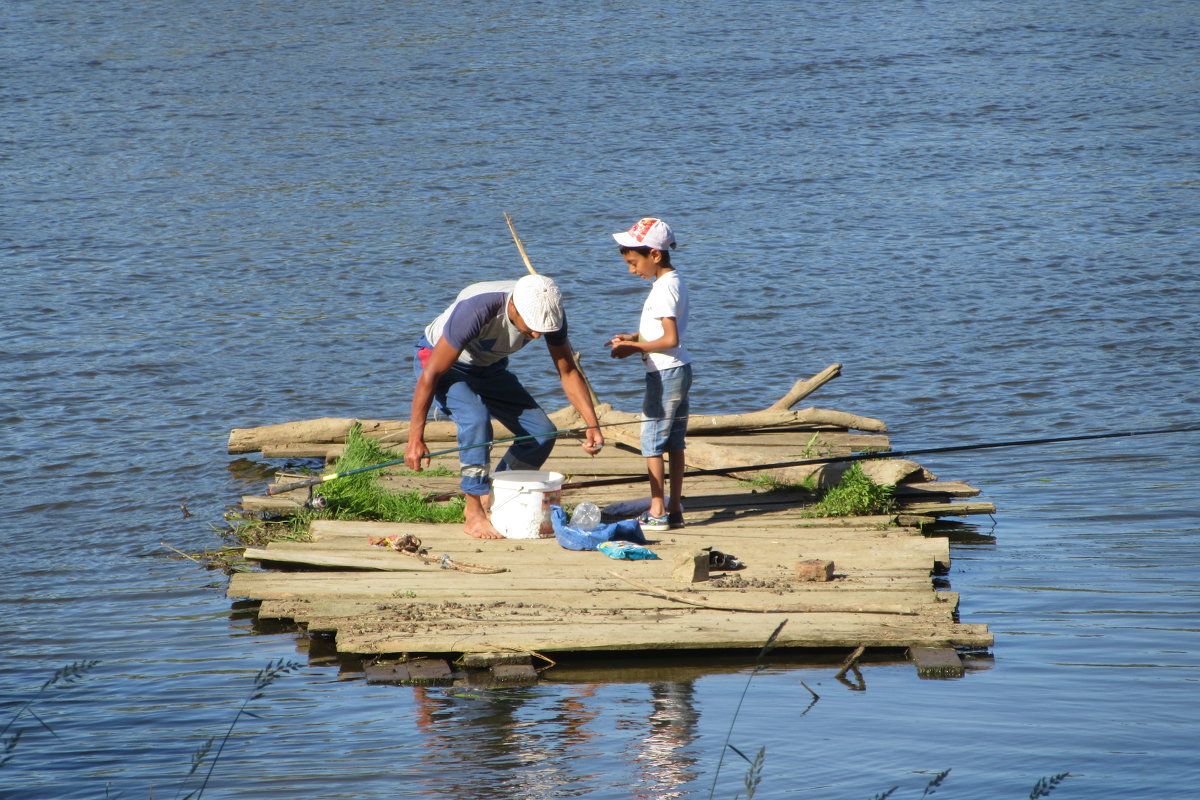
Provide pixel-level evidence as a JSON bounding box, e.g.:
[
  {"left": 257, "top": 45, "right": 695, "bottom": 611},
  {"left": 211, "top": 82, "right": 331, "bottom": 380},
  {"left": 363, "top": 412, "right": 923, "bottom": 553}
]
[{"left": 228, "top": 365, "right": 995, "bottom": 669}]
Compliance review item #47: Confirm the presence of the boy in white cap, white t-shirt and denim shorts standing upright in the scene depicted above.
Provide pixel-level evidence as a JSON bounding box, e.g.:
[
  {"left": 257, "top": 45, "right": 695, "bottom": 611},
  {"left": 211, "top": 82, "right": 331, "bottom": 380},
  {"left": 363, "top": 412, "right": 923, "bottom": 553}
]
[{"left": 608, "top": 217, "right": 691, "bottom": 530}]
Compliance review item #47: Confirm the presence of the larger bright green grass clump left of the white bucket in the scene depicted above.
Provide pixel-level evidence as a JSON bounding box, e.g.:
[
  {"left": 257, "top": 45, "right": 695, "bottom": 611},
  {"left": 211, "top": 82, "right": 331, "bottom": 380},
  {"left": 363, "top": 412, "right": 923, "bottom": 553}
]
[{"left": 309, "top": 426, "right": 464, "bottom": 525}]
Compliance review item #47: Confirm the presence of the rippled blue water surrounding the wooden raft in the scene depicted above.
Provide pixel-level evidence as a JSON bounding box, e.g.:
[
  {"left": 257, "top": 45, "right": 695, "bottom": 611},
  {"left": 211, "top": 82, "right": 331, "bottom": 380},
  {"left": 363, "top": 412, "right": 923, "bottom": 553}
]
[{"left": 0, "top": 0, "right": 1200, "bottom": 800}]
